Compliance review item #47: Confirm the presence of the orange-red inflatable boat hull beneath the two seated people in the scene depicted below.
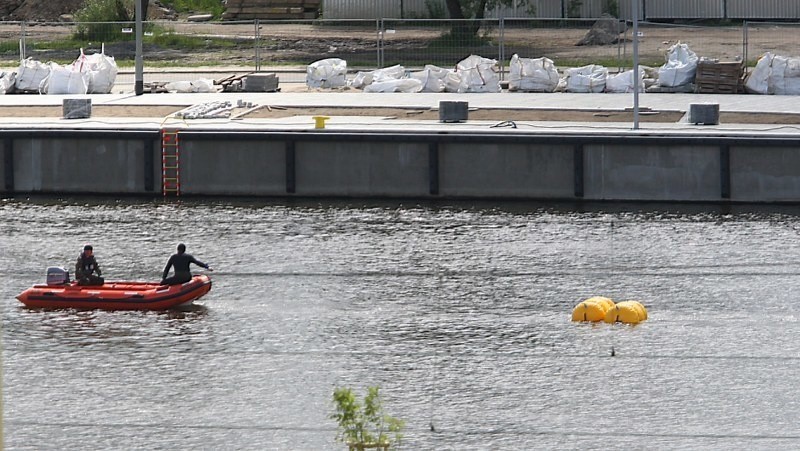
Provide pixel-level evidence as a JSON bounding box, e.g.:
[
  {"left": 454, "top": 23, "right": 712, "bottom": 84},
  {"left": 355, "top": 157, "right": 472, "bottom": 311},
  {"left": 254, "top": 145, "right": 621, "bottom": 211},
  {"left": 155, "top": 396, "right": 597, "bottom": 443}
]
[{"left": 17, "top": 274, "right": 211, "bottom": 310}]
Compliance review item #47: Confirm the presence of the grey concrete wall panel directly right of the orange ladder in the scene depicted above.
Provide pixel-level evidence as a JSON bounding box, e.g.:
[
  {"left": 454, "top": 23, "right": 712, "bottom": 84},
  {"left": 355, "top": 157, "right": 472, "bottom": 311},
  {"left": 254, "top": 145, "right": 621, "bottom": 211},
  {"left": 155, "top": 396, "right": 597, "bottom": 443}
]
[{"left": 180, "top": 138, "right": 286, "bottom": 196}]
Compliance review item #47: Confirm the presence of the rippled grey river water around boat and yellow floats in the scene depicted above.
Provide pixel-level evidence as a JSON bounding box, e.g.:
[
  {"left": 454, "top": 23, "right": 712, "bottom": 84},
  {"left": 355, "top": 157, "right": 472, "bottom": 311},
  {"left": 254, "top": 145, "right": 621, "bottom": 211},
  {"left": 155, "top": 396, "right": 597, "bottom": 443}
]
[{"left": 0, "top": 198, "right": 800, "bottom": 450}]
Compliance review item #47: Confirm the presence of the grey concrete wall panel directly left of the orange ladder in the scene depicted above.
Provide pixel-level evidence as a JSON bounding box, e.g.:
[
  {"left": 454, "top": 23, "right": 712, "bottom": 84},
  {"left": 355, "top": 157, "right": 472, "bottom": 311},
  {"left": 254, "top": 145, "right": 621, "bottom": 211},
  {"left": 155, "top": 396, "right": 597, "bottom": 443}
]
[{"left": 13, "top": 138, "right": 145, "bottom": 194}]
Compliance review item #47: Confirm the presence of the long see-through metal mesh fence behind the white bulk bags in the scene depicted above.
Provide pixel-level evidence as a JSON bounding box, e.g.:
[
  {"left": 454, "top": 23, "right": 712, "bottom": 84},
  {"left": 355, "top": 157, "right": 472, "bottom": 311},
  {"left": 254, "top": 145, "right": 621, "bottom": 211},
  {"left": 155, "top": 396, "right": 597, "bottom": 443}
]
[{"left": 0, "top": 19, "right": 800, "bottom": 86}]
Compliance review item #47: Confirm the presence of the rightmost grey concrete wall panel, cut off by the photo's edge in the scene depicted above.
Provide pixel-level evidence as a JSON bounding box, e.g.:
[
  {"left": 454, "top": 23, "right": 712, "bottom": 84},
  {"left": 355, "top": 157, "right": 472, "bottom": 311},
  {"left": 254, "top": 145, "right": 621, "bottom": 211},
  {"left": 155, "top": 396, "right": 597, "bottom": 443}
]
[{"left": 730, "top": 147, "right": 800, "bottom": 202}]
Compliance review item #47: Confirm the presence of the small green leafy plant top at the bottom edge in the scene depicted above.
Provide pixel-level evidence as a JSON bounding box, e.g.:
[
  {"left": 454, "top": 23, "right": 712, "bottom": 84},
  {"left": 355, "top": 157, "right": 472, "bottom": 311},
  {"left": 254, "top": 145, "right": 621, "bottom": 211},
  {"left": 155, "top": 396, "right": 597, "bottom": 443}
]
[{"left": 330, "top": 387, "right": 403, "bottom": 451}]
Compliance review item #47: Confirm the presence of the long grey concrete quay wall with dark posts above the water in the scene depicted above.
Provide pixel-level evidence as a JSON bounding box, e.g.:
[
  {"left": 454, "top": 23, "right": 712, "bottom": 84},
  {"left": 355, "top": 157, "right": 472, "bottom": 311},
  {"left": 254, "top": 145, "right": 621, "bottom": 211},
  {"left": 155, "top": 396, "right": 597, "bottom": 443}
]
[{"left": 0, "top": 130, "right": 800, "bottom": 203}]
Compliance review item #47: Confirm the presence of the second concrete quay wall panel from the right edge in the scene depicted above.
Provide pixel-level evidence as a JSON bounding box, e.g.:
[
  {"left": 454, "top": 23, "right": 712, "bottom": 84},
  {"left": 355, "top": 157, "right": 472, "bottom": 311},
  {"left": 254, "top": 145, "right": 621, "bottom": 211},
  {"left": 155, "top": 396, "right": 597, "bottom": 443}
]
[{"left": 584, "top": 145, "right": 721, "bottom": 201}]
